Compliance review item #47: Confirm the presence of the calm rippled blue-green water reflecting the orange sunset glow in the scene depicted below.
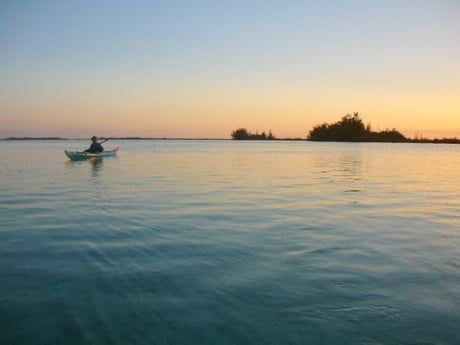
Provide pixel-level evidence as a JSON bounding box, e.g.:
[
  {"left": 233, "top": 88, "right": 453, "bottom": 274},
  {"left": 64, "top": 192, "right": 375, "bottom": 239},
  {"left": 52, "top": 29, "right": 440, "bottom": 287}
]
[{"left": 0, "top": 141, "right": 460, "bottom": 345}]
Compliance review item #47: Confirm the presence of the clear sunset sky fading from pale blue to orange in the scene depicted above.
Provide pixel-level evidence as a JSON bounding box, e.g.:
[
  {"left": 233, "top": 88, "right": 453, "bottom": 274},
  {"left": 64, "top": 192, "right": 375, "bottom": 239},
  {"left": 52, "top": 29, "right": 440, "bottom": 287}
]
[{"left": 0, "top": 0, "right": 460, "bottom": 138}]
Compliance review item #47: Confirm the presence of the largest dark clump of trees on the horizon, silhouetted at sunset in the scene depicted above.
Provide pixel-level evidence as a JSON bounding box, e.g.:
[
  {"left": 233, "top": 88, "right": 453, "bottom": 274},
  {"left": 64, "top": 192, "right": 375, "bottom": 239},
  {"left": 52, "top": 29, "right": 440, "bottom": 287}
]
[{"left": 307, "top": 113, "right": 408, "bottom": 142}]
